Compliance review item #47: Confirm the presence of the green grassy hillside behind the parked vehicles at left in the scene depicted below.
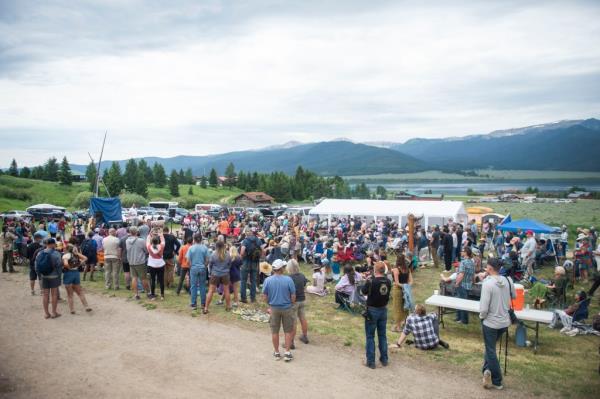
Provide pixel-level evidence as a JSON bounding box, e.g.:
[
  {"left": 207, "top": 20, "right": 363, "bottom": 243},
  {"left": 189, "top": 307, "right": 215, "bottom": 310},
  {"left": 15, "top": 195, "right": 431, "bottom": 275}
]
[{"left": 0, "top": 175, "right": 241, "bottom": 212}]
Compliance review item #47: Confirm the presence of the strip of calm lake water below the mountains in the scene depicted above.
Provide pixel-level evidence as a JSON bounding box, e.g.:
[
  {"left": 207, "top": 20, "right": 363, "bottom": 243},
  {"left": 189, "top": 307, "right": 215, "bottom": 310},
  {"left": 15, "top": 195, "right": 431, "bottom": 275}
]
[{"left": 367, "top": 180, "right": 600, "bottom": 195}]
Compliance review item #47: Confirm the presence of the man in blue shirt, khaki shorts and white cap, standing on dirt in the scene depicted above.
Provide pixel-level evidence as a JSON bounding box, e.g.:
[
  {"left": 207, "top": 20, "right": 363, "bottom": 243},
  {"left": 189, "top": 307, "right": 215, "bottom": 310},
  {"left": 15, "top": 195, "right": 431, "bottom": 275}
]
[{"left": 263, "top": 259, "right": 296, "bottom": 362}]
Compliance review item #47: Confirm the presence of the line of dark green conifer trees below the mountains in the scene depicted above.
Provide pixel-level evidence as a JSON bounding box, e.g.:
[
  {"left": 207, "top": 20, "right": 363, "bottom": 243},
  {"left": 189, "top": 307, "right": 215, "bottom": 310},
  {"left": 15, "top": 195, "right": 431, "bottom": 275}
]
[{"left": 0, "top": 157, "right": 385, "bottom": 203}]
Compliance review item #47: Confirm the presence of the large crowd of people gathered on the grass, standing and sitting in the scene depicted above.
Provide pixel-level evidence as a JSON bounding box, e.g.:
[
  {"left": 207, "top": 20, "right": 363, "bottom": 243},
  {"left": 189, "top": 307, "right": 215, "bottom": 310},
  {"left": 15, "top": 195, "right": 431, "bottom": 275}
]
[{"left": 2, "top": 209, "right": 600, "bottom": 388}]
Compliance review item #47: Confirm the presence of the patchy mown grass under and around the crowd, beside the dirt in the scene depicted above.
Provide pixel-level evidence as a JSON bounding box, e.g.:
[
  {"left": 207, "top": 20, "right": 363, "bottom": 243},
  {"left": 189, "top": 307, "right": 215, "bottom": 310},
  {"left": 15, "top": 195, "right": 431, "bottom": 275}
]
[{"left": 70, "top": 250, "right": 600, "bottom": 398}]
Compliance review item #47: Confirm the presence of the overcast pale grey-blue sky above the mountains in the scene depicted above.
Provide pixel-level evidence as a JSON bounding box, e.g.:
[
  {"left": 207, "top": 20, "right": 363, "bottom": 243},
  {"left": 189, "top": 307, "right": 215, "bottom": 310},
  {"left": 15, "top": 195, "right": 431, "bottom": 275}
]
[{"left": 0, "top": 0, "right": 600, "bottom": 167}]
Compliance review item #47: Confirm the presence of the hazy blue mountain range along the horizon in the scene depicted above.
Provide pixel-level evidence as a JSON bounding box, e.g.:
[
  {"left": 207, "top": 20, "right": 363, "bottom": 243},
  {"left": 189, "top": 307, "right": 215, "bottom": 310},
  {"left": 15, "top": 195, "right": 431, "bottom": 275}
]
[{"left": 71, "top": 119, "right": 600, "bottom": 176}]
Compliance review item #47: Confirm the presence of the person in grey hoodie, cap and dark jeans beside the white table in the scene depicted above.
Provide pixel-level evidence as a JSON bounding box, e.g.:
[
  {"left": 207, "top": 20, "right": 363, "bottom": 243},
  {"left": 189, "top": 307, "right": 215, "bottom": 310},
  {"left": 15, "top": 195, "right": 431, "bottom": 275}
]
[{"left": 479, "top": 258, "right": 516, "bottom": 389}]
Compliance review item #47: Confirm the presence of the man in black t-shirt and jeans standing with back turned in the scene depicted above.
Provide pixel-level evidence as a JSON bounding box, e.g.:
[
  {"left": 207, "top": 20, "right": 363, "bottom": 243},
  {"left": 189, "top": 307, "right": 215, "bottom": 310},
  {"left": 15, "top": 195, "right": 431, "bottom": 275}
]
[{"left": 361, "top": 262, "right": 392, "bottom": 369}]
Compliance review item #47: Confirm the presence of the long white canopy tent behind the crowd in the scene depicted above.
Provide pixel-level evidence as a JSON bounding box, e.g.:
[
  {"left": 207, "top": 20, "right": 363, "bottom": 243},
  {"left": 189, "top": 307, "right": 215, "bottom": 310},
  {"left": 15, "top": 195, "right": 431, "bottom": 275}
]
[{"left": 309, "top": 199, "right": 467, "bottom": 227}]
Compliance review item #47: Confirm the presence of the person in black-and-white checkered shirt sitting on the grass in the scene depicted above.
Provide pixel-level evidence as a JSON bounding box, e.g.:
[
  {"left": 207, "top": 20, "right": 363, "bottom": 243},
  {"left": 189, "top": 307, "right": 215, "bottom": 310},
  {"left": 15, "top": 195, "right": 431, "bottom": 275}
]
[{"left": 396, "top": 303, "right": 450, "bottom": 350}]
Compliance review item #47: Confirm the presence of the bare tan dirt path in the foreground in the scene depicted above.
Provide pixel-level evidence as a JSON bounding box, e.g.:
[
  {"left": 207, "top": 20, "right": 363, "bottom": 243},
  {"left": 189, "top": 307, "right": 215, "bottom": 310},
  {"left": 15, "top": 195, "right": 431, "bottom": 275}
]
[{"left": 0, "top": 273, "right": 523, "bottom": 399}]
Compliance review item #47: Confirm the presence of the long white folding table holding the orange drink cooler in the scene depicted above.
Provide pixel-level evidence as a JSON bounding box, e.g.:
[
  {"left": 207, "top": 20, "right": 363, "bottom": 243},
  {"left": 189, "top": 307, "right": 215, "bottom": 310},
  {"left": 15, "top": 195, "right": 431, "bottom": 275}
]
[{"left": 425, "top": 295, "right": 553, "bottom": 353}]
